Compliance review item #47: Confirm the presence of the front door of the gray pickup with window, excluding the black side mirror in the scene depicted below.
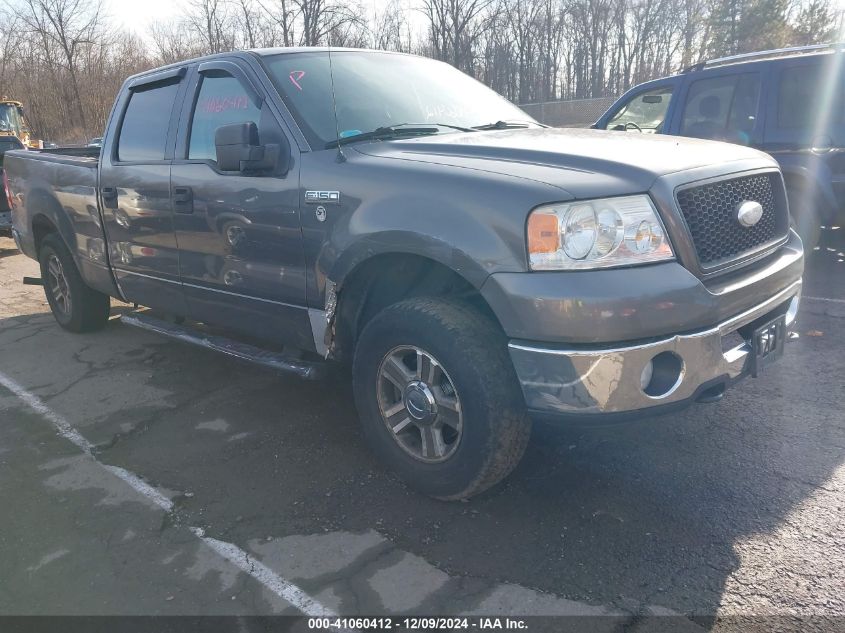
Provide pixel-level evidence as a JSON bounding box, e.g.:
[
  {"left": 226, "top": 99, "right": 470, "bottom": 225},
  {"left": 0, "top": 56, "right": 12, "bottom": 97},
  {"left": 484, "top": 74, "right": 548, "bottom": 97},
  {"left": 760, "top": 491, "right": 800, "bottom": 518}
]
[{"left": 171, "top": 61, "right": 313, "bottom": 349}]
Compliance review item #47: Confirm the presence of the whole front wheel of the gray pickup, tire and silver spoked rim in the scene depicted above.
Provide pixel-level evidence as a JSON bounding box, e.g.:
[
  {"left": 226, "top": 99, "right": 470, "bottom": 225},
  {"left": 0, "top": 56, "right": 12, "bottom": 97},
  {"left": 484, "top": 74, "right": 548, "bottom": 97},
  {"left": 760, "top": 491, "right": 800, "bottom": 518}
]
[{"left": 353, "top": 298, "right": 531, "bottom": 499}]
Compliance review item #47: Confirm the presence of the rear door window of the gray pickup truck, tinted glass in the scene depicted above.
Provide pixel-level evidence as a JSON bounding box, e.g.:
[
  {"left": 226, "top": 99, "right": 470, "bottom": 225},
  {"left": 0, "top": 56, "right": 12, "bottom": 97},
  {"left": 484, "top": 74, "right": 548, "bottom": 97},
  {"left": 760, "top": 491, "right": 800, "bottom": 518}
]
[{"left": 117, "top": 82, "right": 179, "bottom": 161}]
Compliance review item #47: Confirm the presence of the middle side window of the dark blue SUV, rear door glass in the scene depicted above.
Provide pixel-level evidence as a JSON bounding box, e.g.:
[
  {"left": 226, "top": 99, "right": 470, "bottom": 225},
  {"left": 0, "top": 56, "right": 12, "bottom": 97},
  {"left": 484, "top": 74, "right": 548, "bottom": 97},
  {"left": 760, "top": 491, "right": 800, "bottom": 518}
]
[{"left": 681, "top": 73, "right": 760, "bottom": 144}]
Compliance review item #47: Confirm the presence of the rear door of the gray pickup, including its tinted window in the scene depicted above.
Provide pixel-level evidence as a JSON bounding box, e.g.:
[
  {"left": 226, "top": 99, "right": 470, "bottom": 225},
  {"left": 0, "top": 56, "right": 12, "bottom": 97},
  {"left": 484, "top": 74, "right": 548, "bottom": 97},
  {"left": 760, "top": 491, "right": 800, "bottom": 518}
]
[{"left": 99, "top": 68, "right": 186, "bottom": 315}]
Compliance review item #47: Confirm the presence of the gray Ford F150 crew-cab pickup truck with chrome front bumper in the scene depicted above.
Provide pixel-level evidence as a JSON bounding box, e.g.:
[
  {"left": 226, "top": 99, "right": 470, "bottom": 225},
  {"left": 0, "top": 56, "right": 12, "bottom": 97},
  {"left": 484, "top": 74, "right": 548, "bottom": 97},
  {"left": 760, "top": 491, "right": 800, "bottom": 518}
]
[{"left": 6, "top": 49, "right": 803, "bottom": 499}]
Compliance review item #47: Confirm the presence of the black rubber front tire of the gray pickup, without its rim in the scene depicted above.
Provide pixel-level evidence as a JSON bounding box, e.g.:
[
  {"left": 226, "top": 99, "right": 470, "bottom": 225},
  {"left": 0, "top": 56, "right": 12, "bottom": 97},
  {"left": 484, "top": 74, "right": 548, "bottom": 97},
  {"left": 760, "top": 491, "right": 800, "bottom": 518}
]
[{"left": 352, "top": 298, "right": 531, "bottom": 500}]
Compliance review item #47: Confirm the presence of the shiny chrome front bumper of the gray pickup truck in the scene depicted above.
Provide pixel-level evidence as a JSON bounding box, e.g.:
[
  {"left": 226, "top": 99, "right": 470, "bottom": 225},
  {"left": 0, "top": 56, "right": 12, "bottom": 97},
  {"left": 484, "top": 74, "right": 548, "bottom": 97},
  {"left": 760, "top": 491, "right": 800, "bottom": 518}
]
[{"left": 508, "top": 281, "right": 801, "bottom": 416}]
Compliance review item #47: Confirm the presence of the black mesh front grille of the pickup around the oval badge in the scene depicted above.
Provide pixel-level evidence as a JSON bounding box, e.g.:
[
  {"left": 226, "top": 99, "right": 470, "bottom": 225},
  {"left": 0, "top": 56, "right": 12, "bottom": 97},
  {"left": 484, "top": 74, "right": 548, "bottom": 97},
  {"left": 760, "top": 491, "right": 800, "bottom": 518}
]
[{"left": 677, "top": 173, "right": 789, "bottom": 269}]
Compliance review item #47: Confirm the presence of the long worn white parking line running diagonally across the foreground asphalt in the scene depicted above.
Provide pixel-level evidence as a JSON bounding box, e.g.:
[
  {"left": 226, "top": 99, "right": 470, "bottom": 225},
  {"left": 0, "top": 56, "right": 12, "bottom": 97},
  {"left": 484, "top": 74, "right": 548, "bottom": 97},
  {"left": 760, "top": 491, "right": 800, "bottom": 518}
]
[{"left": 0, "top": 373, "right": 336, "bottom": 617}]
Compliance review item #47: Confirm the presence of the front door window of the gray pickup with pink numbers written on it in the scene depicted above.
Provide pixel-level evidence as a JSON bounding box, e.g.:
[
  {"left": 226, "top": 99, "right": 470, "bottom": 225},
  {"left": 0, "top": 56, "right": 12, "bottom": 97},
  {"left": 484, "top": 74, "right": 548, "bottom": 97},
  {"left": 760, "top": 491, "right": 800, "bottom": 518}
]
[{"left": 188, "top": 73, "right": 261, "bottom": 160}]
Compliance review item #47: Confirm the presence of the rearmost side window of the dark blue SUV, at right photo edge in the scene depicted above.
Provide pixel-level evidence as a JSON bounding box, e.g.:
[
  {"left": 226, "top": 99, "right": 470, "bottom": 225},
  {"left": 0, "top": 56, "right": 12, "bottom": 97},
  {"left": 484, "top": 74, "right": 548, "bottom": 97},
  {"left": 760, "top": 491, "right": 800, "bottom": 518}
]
[{"left": 778, "top": 64, "right": 845, "bottom": 130}]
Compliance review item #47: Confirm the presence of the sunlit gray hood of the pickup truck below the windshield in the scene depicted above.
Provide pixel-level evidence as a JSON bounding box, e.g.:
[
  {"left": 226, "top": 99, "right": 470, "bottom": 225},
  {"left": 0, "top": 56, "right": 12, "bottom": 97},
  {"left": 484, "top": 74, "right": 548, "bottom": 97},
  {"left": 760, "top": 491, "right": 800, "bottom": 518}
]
[{"left": 355, "top": 128, "right": 775, "bottom": 198}]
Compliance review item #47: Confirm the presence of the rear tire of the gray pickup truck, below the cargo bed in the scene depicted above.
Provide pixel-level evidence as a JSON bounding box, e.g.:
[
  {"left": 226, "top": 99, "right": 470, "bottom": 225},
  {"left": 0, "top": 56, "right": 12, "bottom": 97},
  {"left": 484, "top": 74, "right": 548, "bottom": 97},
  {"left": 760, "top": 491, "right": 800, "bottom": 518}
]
[{"left": 38, "top": 233, "right": 111, "bottom": 332}]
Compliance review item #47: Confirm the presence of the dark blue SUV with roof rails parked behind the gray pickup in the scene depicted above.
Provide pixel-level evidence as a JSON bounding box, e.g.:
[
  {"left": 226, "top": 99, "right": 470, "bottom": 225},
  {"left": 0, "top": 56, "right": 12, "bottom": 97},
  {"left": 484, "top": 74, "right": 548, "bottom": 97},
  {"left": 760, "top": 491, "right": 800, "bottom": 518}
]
[{"left": 593, "top": 44, "right": 845, "bottom": 249}]
